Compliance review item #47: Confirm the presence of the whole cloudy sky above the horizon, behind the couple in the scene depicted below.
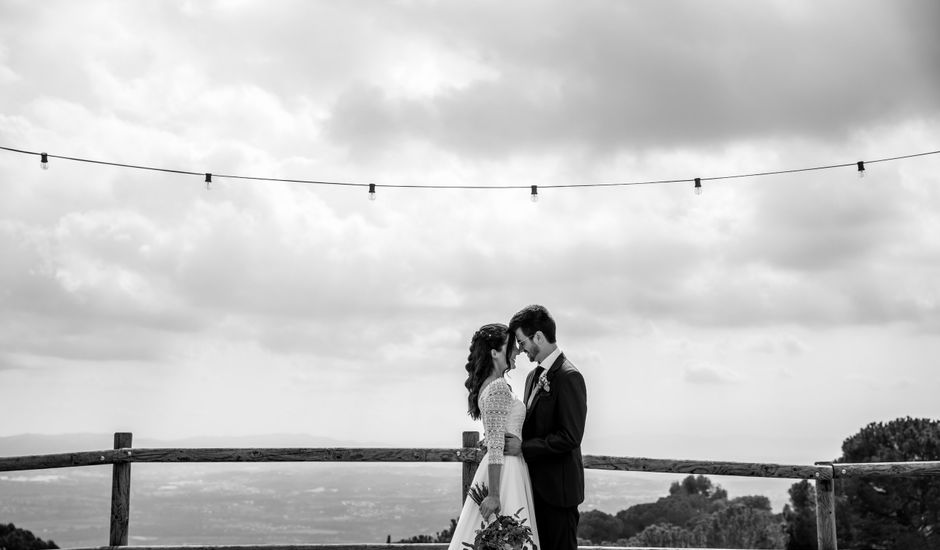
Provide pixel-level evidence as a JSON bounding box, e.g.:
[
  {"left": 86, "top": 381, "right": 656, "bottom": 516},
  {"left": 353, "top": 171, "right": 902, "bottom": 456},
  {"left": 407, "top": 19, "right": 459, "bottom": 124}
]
[{"left": 0, "top": 0, "right": 940, "bottom": 476}]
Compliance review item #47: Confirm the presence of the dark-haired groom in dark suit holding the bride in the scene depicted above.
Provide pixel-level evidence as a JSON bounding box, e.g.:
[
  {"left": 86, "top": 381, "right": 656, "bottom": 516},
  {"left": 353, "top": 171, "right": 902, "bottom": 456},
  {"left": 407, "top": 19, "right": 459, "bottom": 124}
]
[{"left": 505, "top": 305, "right": 587, "bottom": 550}]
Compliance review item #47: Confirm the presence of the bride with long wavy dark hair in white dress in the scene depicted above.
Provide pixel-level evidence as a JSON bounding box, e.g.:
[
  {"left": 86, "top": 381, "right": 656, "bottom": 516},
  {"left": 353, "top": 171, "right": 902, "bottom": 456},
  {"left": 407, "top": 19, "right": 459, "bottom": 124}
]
[{"left": 448, "top": 323, "right": 539, "bottom": 550}]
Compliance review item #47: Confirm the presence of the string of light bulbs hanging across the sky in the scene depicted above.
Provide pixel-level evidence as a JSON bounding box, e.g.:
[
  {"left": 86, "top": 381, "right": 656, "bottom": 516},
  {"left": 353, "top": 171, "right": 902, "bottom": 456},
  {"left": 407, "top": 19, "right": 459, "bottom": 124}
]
[{"left": 0, "top": 145, "right": 940, "bottom": 202}]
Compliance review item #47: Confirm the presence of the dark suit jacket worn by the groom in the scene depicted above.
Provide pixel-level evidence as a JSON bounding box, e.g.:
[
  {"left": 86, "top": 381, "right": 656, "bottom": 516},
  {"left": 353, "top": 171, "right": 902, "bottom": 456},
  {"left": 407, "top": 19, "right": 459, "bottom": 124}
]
[{"left": 522, "top": 354, "right": 587, "bottom": 507}]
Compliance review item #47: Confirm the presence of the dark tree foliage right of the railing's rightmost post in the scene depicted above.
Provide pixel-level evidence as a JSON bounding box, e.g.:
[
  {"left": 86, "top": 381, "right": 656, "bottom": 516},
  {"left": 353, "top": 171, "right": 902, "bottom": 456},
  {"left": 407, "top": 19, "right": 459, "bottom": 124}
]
[{"left": 836, "top": 417, "right": 940, "bottom": 550}]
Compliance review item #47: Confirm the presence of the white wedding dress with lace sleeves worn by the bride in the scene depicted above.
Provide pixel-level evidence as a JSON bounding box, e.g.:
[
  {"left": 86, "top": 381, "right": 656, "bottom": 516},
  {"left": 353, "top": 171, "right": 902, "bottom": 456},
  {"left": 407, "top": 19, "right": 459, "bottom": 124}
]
[{"left": 448, "top": 378, "right": 540, "bottom": 550}]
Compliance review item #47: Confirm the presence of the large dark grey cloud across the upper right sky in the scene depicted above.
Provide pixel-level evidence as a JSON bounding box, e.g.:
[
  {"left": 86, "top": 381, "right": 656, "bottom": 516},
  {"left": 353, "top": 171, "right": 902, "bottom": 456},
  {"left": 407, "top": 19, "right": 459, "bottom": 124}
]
[{"left": 314, "top": 3, "right": 940, "bottom": 158}]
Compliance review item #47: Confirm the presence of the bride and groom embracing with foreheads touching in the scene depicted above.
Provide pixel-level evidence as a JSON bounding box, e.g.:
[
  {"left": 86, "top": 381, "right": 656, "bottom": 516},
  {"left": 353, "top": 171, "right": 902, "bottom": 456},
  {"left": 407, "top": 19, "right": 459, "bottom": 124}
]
[{"left": 449, "top": 305, "right": 587, "bottom": 550}]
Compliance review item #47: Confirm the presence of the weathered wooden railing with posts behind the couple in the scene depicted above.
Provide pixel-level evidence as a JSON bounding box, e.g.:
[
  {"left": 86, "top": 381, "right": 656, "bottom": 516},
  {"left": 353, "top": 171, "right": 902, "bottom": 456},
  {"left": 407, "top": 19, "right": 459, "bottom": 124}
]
[{"left": 0, "top": 432, "right": 940, "bottom": 550}]
